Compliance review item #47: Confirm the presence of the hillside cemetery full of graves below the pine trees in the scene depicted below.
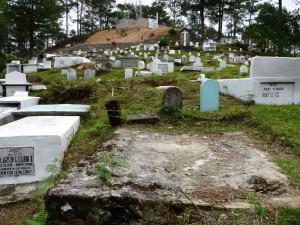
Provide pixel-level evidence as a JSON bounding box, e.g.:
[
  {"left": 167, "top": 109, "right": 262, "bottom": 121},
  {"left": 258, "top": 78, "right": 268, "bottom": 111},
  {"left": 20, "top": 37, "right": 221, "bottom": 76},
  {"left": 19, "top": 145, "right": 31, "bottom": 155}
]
[{"left": 0, "top": 3, "right": 300, "bottom": 225}]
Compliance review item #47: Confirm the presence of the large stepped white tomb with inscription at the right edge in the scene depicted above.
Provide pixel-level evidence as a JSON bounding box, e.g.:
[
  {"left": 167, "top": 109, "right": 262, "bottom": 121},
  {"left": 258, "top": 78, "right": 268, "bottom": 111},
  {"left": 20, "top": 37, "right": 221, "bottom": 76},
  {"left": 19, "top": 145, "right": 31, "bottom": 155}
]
[{"left": 218, "top": 57, "right": 300, "bottom": 105}]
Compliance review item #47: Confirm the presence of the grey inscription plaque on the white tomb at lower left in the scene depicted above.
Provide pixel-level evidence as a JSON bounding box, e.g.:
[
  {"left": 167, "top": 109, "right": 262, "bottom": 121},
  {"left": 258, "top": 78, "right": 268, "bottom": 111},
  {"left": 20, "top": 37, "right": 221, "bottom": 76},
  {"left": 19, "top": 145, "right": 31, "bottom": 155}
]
[{"left": 0, "top": 147, "right": 34, "bottom": 177}]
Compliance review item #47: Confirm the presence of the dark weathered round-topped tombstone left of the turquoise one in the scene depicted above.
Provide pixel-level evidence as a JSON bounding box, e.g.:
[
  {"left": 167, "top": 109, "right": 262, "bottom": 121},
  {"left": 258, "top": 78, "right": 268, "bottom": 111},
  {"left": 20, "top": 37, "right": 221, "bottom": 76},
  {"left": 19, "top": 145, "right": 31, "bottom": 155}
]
[{"left": 163, "top": 87, "right": 182, "bottom": 113}]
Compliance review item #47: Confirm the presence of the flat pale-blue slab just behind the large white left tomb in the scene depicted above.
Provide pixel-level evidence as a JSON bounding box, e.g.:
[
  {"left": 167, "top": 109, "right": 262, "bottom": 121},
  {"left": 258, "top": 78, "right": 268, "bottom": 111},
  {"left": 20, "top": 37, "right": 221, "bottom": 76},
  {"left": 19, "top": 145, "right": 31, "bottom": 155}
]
[{"left": 13, "top": 104, "right": 90, "bottom": 118}]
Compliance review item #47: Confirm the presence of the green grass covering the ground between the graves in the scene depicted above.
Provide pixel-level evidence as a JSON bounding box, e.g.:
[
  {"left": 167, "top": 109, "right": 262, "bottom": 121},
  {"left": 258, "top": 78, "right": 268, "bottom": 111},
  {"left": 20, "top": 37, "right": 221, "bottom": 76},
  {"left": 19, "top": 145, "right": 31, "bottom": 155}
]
[{"left": 5, "top": 48, "right": 300, "bottom": 225}]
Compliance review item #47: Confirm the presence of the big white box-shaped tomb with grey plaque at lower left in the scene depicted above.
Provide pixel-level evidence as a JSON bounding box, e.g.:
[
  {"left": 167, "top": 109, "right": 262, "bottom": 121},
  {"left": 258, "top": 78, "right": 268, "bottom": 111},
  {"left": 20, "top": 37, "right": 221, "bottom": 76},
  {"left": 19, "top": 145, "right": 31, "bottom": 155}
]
[{"left": 0, "top": 116, "right": 80, "bottom": 184}]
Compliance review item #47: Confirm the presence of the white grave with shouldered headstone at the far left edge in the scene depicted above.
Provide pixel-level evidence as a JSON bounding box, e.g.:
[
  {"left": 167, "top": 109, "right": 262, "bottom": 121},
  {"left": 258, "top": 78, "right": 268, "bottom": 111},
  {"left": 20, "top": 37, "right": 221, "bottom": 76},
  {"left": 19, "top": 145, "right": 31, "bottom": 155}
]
[{"left": 2, "top": 71, "right": 31, "bottom": 97}]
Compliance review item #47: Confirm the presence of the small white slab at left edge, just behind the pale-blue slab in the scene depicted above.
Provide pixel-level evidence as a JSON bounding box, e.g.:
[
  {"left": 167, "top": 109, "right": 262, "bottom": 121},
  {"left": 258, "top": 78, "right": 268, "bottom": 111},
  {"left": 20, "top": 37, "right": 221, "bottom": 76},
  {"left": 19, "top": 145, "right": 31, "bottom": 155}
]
[{"left": 0, "top": 96, "right": 40, "bottom": 109}]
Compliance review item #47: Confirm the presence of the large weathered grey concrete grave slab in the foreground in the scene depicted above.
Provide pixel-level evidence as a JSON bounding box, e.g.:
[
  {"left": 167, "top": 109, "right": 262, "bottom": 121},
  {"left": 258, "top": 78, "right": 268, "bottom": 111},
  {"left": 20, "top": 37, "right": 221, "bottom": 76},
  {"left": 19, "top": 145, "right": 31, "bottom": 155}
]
[{"left": 45, "top": 129, "right": 288, "bottom": 224}]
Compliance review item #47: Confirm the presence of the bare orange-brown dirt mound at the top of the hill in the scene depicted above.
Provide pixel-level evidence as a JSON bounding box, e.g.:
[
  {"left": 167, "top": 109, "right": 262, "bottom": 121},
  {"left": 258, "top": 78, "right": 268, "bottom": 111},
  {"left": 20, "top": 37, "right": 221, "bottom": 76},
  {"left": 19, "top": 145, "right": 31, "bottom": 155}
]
[{"left": 84, "top": 27, "right": 171, "bottom": 44}]
